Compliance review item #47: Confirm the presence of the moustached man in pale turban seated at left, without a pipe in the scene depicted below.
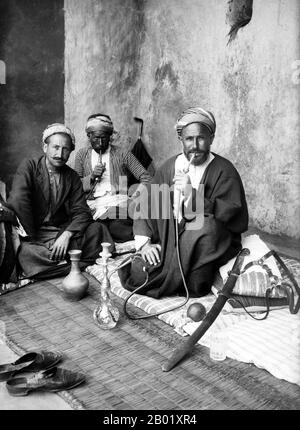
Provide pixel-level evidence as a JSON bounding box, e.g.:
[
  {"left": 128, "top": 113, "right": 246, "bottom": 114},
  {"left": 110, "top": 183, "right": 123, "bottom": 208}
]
[{"left": 7, "top": 123, "right": 109, "bottom": 279}]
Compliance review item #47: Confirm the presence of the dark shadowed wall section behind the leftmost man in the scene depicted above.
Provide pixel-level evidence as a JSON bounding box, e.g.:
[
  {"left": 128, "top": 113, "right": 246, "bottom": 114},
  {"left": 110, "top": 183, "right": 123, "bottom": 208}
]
[{"left": 0, "top": 0, "right": 64, "bottom": 188}]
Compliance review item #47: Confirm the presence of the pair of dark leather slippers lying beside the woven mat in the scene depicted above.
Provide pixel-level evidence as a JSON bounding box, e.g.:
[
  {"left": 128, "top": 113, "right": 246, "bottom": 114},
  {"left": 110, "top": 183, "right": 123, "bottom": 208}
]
[{"left": 0, "top": 351, "right": 85, "bottom": 397}]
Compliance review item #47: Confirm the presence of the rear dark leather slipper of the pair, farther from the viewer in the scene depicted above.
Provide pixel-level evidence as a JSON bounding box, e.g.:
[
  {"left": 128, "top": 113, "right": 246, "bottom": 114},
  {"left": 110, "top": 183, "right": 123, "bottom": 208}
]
[{"left": 0, "top": 351, "right": 62, "bottom": 381}]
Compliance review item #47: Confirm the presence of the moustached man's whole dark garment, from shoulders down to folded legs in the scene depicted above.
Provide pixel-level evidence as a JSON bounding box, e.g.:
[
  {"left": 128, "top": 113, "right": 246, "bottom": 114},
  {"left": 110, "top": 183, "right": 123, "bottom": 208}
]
[{"left": 7, "top": 156, "right": 112, "bottom": 279}]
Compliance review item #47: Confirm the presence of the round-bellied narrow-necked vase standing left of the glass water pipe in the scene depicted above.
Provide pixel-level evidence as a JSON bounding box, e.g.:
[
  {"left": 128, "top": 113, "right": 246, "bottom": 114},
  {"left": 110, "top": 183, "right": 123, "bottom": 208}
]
[{"left": 62, "top": 249, "right": 89, "bottom": 302}]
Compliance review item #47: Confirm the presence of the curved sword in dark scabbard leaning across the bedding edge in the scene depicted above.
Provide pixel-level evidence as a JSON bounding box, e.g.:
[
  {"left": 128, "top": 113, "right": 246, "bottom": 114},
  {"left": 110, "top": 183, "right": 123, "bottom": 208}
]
[{"left": 162, "top": 248, "right": 250, "bottom": 372}]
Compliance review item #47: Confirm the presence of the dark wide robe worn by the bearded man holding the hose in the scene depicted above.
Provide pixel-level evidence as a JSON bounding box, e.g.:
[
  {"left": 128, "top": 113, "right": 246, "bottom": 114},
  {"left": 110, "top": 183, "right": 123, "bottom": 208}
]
[{"left": 119, "top": 154, "right": 248, "bottom": 298}]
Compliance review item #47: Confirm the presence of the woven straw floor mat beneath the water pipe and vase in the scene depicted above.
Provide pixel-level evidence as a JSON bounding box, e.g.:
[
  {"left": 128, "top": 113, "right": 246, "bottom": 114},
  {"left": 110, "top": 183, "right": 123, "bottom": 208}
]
[{"left": 0, "top": 275, "right": 300, "bottom": 410}]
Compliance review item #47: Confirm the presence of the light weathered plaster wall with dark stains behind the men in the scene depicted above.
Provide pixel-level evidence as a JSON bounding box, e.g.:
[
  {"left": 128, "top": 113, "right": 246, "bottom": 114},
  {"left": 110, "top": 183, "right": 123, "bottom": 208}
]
[{"left": 65, "top": 0, "right": 300, "bottom": 238}]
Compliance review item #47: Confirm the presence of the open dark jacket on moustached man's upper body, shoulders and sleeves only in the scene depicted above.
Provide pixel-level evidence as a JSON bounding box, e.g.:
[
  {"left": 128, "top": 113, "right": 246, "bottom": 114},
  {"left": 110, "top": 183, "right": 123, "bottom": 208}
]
[{"left": 7, "top": 156, "right": 93, "bottom": 238}]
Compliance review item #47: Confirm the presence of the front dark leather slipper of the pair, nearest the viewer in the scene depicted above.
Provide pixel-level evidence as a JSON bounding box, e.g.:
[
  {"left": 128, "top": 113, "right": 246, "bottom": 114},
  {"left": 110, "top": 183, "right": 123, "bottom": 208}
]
[{"left": 6, "top": 367, "right": 85, "bottom": 397}]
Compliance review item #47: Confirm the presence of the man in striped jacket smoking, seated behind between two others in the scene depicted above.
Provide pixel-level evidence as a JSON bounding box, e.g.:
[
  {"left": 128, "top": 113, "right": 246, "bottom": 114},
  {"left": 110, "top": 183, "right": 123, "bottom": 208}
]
[{"left": 75, "top": 114, "right": 151, "bottom": 242}]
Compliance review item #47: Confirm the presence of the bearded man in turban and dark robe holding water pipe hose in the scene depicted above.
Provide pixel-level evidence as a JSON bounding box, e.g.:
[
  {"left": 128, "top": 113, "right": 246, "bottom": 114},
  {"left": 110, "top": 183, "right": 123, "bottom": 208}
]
[{"left": 119, "top": 107, "right": 248, "bottom": 298}]
